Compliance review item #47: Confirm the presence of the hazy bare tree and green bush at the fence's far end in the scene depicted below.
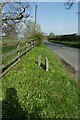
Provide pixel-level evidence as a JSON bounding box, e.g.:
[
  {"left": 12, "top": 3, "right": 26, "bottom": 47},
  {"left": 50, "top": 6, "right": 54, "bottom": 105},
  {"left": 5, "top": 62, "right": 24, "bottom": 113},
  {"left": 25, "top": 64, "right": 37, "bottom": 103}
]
[{"left": 24, "top": 20, "right": 45, "bottom": 45}]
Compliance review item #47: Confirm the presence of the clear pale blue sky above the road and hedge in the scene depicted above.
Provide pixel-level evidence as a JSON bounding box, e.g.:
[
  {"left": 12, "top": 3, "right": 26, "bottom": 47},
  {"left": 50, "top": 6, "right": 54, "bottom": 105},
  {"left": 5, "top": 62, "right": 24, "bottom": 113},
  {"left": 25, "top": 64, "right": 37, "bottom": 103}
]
[{"left": 30, "top": 2, "right": 78, "bottom": 34}]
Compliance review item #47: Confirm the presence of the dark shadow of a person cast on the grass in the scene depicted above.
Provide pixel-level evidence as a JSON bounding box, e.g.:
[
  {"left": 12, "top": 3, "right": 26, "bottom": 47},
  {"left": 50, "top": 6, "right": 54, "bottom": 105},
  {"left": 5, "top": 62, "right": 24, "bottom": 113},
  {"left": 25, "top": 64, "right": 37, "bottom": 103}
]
[{"left": 2, "top": 88, "right": 26, "bottom": 120}]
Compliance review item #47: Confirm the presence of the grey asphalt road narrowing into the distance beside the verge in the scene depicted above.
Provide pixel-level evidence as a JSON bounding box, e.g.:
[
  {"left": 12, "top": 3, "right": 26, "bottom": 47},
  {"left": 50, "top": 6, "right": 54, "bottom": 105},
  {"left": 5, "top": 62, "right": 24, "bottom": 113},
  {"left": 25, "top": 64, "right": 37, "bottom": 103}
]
[{"left": 43, "top": 40, "right": 78, "bottom": 71}]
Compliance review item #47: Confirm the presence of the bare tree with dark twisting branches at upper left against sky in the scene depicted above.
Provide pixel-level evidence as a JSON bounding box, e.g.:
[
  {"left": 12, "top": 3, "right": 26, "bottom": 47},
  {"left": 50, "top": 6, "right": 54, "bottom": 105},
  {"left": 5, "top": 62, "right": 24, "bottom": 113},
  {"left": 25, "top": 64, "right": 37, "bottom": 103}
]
[{"left": 0, "top": 0, "right": 31, "bottom": 35}]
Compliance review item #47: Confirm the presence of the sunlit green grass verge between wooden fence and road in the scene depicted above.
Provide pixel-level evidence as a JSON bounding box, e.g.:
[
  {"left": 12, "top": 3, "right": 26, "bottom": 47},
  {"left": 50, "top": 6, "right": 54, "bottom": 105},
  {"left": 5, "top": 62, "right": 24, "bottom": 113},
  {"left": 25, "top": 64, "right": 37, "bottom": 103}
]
[{"left": 2, "top": 45, "right": 78, "bottom": 120}]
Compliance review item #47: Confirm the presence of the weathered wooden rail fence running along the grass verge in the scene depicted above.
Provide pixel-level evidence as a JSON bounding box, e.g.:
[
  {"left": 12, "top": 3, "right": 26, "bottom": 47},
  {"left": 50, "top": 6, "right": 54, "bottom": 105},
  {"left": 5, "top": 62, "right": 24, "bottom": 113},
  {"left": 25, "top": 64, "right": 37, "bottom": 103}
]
[{"left": 0, "top": 40, "right": 37, "bottom": 77}]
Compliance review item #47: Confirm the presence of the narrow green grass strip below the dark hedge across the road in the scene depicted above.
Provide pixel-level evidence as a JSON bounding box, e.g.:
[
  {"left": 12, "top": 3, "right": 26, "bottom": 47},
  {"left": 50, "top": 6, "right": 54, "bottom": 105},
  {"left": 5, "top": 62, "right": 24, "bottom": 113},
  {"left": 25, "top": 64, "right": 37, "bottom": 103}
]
[{"left": 49, "top": 40, "right": 80, "bottom": 48}]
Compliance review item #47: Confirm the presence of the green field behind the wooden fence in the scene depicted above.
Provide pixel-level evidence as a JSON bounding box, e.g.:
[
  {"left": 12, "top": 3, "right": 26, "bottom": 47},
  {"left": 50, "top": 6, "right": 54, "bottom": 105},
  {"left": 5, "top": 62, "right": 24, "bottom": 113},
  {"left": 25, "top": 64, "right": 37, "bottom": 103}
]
[{"left": 0, "top": 39, "right": 26, "bottom": 65}]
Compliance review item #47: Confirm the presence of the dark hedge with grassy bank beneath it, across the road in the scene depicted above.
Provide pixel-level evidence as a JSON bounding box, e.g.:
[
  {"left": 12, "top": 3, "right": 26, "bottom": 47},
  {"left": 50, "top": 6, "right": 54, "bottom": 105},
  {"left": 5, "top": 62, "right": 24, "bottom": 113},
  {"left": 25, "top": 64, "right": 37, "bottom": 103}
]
[{"left": 48, "top": 33, "right": 80, "bottom": 48}]
